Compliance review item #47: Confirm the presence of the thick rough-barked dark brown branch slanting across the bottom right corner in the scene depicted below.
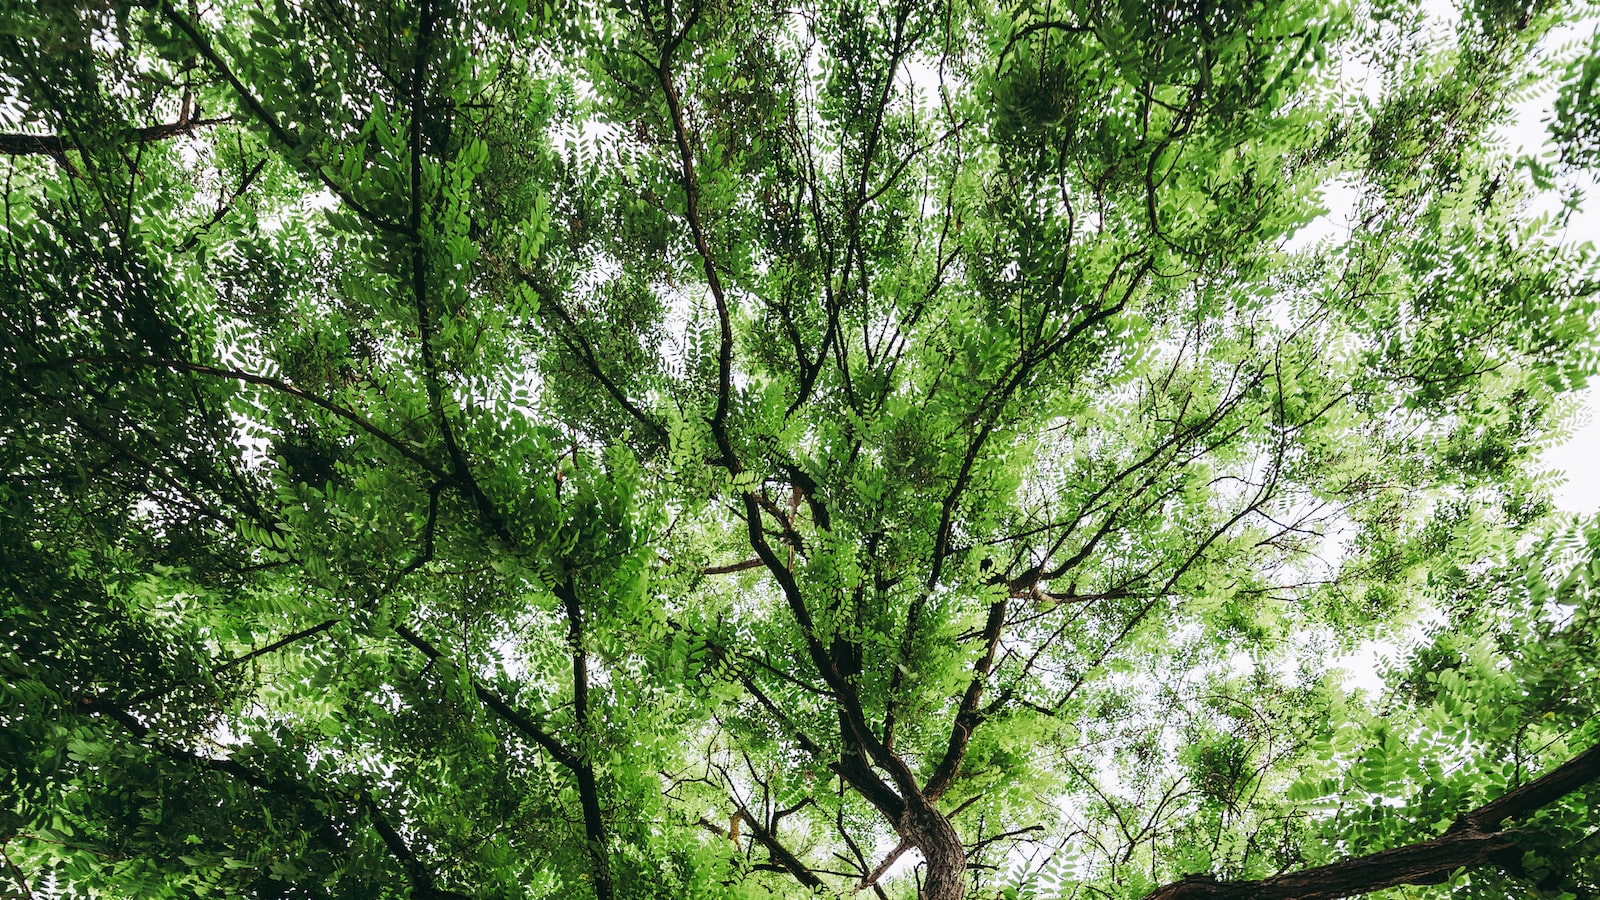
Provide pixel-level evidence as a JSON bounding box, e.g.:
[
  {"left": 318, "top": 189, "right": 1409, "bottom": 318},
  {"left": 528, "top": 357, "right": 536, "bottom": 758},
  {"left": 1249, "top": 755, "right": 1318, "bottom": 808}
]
[{"left": 1146, "top": 745, "right": 1600, "bottom": 900}]
